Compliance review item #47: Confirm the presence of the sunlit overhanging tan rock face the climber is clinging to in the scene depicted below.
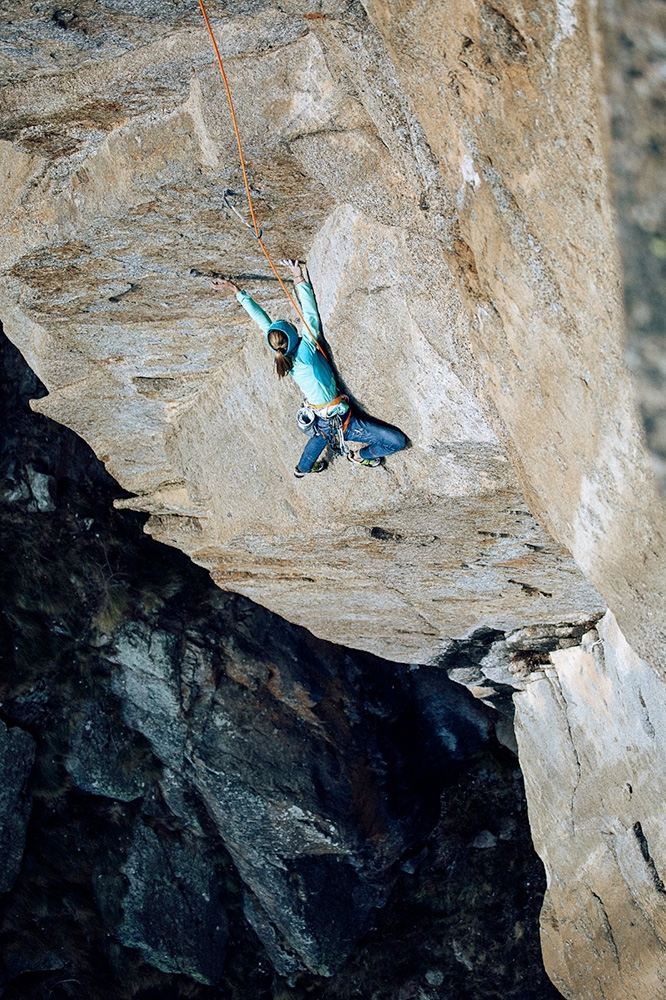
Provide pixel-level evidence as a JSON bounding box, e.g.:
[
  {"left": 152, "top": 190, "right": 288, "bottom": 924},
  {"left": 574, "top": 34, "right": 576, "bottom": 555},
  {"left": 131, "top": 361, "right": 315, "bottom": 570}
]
[{"left": 3, "top": 5, "right": 603, "bottom": 661}]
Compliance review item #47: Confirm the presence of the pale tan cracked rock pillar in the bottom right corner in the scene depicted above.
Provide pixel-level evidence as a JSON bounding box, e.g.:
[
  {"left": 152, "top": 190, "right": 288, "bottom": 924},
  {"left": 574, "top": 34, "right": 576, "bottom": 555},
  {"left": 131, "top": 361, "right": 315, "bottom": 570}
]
[{"left": 515, "top": 612, "right": 666, "bottom": 1000}]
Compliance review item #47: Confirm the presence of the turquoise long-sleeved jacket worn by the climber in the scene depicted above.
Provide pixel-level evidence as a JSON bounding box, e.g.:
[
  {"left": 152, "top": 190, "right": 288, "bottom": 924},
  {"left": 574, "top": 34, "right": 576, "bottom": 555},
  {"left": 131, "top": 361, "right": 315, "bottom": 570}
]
[{"left": 236, "top": 281, "right": 347, "bottom": 412}]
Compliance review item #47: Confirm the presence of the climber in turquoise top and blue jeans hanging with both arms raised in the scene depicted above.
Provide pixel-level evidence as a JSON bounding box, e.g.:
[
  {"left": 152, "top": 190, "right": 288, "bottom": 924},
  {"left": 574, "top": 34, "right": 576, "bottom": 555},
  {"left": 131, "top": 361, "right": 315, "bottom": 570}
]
[{"left": 210, "top": 260, "right": 407, "bottom": 479}]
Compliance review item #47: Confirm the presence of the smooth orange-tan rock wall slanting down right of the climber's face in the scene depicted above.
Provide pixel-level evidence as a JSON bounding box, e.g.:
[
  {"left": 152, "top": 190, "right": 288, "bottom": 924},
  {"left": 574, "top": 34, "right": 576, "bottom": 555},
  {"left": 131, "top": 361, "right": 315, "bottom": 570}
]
[{"left": 358, "top": 0, "right": 666, "bottom": 680}]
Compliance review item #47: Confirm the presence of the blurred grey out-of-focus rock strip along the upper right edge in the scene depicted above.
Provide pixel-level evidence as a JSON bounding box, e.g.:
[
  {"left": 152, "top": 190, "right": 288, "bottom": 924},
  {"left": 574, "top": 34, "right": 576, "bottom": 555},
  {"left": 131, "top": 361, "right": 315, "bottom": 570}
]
[{"left": 598, "top": 0, "right": 666, "bottom": 496}]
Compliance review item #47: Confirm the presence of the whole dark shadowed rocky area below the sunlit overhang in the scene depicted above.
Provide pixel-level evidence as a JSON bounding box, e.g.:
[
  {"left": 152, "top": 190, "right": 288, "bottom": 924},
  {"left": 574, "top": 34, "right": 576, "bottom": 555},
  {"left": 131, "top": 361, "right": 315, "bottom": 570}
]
[{"left": 0, "top": 324, "right": 558, "bottom": 1000}]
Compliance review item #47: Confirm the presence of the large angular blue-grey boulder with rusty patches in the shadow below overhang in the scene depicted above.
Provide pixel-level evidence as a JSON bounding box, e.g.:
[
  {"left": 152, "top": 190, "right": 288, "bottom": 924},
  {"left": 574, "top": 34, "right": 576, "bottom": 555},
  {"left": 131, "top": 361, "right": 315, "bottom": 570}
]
[{"left": 107, "top": 592, "right": 490, "bottom": 975}]
